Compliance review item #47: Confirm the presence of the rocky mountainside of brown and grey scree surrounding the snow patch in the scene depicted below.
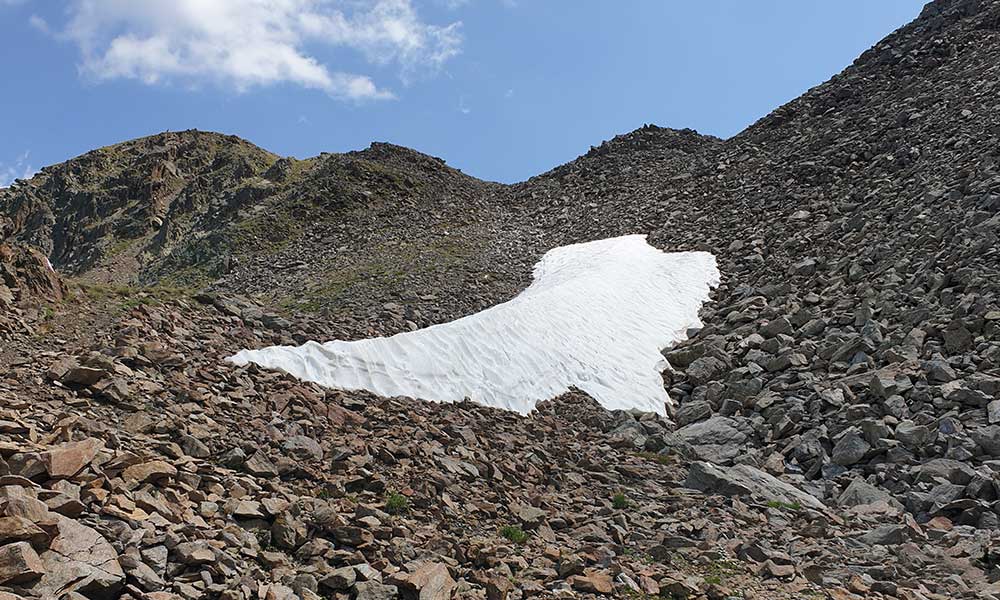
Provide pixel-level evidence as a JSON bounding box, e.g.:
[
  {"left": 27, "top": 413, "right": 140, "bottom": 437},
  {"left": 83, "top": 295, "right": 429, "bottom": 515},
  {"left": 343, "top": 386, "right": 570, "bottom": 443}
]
[{"left": 0, "top": 0, "right": 1000, "bottom": 600}]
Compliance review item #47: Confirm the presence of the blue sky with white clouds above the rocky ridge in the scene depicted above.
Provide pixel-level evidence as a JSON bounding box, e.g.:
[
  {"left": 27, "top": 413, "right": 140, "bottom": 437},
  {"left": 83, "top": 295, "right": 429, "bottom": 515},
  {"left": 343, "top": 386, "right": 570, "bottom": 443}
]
[{"left": 0, "top": 0, "right": 923, "bottom": 185}]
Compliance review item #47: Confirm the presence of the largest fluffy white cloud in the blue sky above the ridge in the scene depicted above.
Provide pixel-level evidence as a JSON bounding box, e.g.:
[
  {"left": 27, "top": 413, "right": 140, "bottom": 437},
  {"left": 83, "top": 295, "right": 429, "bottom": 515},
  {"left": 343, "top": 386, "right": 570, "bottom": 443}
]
[{"left": 47, "top": 0, "right": 462, "bottom": 100}]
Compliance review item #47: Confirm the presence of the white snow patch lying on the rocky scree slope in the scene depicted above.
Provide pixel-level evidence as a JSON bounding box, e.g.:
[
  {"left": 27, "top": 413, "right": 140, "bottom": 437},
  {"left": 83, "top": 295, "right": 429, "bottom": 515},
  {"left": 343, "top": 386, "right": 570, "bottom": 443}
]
[{"left": 228, "top": 235, "right": 719, "bottom": 414}]
